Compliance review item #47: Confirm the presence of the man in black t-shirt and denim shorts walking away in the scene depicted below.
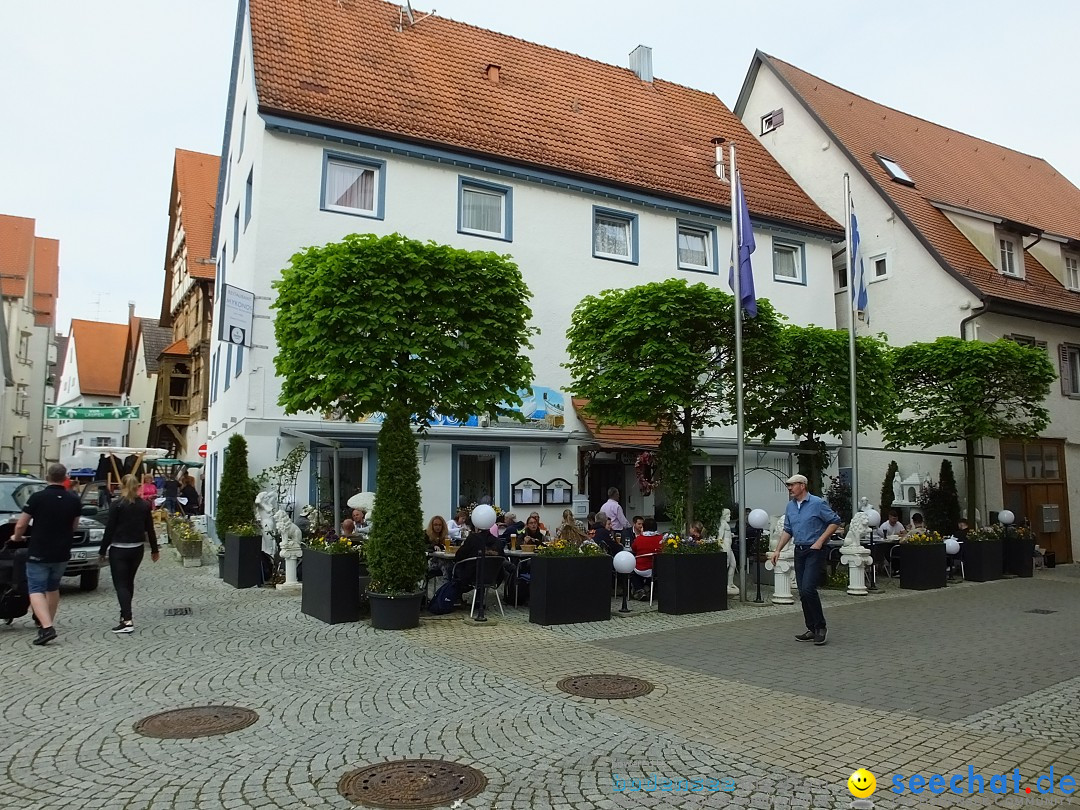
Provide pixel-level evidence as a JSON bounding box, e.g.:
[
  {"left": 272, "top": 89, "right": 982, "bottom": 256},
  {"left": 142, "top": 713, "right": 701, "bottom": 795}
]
[{"left": 12, "top": 464, "right": 82, "bottom": 646}]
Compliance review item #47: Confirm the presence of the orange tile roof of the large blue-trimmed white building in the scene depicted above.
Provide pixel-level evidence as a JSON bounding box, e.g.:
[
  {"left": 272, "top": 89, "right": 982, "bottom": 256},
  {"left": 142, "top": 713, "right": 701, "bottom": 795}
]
[{"left": 249, "top": 0, "right": 838, "bottom": 235}]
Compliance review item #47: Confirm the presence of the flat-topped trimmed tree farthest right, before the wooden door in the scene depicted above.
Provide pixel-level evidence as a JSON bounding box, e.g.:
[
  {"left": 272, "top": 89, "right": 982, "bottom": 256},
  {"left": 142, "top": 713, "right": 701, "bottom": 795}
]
[{"left": 885, "top": 337, "right": 1056, "bottom": 525}]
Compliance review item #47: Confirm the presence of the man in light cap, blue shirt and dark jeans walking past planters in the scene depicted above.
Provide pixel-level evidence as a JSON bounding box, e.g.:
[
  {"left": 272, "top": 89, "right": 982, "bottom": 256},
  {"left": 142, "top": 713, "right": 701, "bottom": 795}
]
[{"left": 772, "top": 475, "right": 840, "bottom": 647}]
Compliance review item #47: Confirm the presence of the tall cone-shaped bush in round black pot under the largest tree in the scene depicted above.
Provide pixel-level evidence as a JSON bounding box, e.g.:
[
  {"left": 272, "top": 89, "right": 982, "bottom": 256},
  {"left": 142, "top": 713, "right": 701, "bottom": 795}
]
[{"left": 364, "top": 404, "right": 427, "bottom": 594}]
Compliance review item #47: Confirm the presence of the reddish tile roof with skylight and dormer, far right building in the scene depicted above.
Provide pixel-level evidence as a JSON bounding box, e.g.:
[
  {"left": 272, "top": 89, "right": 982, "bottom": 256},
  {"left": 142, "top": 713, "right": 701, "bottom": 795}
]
[{"left": 757, "top": 53, "right": 1080, "bottom": 313}]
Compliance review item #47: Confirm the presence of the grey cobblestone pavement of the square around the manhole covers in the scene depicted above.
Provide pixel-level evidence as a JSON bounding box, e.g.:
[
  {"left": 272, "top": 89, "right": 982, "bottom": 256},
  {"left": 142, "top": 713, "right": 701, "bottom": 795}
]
[{"left": 0, "top": 555, "right": 1080, "bottom": 810}]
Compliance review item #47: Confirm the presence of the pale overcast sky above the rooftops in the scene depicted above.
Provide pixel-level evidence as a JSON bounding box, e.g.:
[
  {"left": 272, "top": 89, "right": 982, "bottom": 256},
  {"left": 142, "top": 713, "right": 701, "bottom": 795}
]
[{"left": 0, "top": 0, "right": 1080, "bottom": 332}]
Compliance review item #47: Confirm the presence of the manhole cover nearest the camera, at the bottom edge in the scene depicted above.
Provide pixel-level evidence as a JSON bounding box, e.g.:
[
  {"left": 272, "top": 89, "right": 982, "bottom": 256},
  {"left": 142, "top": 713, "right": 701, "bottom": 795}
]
[{"left": 338, "top": 759, "right": 487, "bottom": 808}]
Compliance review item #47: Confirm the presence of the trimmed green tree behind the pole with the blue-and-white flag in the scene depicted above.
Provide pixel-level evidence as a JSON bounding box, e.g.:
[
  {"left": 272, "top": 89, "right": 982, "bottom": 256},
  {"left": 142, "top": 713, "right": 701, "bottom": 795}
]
[{"left": 746, "top": 324, "right": 893, "bottom": 492}]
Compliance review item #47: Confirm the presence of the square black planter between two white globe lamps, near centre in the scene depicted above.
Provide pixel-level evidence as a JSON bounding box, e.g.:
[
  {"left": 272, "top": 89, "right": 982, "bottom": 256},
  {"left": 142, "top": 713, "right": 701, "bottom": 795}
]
[{"left": 529, "top": 554, "right": 612, "bottom": 624}]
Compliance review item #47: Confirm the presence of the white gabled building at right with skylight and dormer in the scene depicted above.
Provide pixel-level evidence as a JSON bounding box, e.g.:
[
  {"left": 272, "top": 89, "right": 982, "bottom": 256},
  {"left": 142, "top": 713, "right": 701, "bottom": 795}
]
[{"left": 735, "top": 52, "right": 1080, "bottom": 562}]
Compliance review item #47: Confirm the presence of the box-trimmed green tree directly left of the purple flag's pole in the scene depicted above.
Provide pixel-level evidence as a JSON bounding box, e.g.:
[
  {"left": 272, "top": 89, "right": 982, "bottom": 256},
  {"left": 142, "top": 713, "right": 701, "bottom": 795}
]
[{"left": 566, "top": 279, "right": 780, "bottom": 529}]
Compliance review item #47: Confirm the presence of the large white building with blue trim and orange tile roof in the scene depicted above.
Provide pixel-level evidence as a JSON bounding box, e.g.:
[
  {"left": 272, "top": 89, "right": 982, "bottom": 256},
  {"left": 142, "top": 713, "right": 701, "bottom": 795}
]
[{"left": 206, "top": 0, "right": 842, "bottom": 533}]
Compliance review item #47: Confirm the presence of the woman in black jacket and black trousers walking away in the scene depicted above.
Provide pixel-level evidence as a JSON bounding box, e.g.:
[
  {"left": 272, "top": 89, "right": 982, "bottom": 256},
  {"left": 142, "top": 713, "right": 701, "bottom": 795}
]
[{"left": 97, "top": 475, "right": 161, "bottom": 634}]
